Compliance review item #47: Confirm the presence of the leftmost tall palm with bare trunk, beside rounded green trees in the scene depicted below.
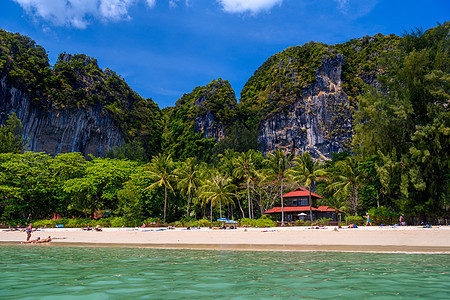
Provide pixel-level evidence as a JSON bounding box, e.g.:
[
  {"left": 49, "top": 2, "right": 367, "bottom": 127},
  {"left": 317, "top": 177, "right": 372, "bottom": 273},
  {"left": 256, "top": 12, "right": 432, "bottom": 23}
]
[{"left": 145, "top": 153, "right": 176, "bottom": 223}]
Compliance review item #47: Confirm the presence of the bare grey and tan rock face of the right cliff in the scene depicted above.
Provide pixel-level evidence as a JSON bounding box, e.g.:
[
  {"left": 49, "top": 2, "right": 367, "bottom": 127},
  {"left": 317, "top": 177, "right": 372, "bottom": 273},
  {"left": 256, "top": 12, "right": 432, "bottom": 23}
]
[{"left": 258, "top": 55, "right": 352, "bottom": 159}]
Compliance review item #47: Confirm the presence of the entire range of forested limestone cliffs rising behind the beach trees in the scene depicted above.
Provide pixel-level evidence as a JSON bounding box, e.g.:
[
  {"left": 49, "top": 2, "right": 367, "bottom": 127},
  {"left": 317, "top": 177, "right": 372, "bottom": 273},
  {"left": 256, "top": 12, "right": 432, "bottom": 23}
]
[{"left": 0, "top": 23, "right": 449, "bottom": 160}]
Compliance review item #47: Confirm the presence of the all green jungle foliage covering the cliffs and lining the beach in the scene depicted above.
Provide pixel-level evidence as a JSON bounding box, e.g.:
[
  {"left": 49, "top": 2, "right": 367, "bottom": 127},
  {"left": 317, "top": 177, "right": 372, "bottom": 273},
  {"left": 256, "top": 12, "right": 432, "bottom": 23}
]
[{"left": 0, "top": 22, "right": 450, "bottom": 224}]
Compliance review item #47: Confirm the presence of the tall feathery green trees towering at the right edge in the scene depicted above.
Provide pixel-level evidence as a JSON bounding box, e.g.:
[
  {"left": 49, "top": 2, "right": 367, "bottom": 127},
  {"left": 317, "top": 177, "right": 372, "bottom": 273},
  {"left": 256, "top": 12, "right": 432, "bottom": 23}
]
[{"left": 353, "top": 22, "right": 450, "bottom": 218}]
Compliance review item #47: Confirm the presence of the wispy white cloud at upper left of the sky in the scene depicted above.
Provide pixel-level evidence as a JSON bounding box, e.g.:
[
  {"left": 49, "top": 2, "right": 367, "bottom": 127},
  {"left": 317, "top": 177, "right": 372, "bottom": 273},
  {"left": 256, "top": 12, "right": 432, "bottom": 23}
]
[{"left": 14, "top": 0, "right": 144, "bottom": 29}]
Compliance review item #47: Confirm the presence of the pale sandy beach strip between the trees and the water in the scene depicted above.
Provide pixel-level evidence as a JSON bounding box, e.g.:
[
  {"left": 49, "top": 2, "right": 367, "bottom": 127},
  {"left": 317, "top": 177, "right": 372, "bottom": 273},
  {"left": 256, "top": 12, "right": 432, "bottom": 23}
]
[{"left": 0, "top": 226, "right": 450, "bottom": 253}]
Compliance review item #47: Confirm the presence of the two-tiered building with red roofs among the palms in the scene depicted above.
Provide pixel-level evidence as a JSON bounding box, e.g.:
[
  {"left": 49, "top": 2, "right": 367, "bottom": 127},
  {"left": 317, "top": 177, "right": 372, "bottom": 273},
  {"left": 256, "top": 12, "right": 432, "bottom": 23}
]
[{"left": 264, "top": 187, "right": 342, "bottom": 222}]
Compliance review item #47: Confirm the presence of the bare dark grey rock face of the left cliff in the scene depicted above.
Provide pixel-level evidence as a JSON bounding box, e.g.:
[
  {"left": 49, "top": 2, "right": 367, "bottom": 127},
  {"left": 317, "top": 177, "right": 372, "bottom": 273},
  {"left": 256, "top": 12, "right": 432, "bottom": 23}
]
[{"left": 0, "top": 77, "right": 124, "bottom": 156}]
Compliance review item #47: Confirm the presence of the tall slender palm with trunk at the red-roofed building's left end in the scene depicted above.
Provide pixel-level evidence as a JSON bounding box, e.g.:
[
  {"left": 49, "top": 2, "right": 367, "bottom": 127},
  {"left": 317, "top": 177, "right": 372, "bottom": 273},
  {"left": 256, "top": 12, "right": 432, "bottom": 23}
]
[{"left": 266, "top": 149, "right": 294, "bottom": 224}]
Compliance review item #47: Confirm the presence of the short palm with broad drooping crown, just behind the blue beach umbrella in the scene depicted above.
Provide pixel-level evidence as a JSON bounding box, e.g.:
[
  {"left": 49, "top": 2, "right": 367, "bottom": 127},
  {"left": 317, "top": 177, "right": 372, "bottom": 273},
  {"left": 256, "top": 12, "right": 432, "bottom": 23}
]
[{"left": 201, "top": 173, "right": 236, "bottom": 222}]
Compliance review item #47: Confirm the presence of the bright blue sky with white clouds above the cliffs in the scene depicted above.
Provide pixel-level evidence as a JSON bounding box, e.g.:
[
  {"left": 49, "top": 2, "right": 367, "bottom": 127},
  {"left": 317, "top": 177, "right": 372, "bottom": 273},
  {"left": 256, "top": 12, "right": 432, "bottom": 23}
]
[{"left": 0, "top": 0, "right": 450, "bottom": 108}]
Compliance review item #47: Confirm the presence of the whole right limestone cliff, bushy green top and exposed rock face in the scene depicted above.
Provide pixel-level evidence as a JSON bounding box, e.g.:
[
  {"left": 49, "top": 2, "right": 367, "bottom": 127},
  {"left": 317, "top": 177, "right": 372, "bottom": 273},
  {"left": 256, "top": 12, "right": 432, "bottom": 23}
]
[{"left": 239, "top": 34, "right": 398, "bottom": 159}]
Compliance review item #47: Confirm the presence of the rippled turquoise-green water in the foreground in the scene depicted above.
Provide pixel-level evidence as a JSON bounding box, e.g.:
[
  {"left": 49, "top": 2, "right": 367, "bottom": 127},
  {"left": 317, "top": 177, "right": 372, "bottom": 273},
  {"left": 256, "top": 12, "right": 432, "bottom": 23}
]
[{"left": 0, "top": 245, "right": 450, "bottom": 299}]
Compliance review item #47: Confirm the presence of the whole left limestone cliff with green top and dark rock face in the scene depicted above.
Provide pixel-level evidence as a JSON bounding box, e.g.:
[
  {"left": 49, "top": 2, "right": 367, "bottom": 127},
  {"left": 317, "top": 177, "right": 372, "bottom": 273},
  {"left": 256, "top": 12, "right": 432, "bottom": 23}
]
[{"left": 0, "top": 29, "right": 162, "bottom": 156}]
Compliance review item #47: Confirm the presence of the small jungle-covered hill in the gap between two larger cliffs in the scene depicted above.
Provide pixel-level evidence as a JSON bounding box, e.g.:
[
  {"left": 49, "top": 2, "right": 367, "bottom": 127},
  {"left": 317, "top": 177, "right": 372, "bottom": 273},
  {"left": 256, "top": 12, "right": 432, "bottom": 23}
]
[{"left": 163, "top": 79, "right": 241, "bottom": 161}]
